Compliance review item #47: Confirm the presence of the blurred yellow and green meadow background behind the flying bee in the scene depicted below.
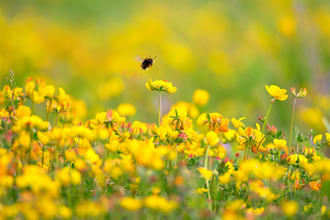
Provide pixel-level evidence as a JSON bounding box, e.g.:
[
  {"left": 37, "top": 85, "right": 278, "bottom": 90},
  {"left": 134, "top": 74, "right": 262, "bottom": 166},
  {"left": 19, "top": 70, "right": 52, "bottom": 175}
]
[{"left": 0, "top": 0, "right": 330, "bottom": 136}]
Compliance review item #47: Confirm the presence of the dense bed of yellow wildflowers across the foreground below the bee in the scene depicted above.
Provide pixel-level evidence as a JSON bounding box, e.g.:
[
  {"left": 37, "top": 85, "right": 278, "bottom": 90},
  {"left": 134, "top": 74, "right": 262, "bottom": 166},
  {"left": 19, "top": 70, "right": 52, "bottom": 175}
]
[{"left": 0, "top": 78, "right": 330, "bottom": 219}]
